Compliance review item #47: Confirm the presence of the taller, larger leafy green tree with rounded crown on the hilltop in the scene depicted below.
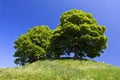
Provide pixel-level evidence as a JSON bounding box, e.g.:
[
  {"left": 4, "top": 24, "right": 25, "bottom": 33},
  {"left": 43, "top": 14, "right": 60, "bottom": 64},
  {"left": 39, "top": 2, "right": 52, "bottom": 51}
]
[{"left": 50, "top": 9, "right": 108, "bottom": 58}]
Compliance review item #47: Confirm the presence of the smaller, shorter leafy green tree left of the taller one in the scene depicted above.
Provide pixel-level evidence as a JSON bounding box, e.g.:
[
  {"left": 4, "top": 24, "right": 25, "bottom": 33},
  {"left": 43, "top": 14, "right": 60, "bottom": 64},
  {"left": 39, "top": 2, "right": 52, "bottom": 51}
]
[{"left": 14, "top": 26, "right": 52, "bottom": 65}]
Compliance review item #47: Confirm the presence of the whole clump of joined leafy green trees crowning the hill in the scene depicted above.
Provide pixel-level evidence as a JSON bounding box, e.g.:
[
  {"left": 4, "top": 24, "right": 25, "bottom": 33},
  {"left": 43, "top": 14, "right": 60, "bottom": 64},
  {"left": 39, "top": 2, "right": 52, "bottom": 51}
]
[{"left": 14, "top": 9, "right": 107, "bottom": 65}]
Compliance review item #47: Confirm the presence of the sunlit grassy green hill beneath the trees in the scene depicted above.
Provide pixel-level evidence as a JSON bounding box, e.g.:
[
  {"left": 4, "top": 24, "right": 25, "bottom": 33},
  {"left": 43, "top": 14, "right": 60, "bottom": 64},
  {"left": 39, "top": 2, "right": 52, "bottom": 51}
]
[{"left": 0, "top": 59, "right": 120, "bottom": 80}]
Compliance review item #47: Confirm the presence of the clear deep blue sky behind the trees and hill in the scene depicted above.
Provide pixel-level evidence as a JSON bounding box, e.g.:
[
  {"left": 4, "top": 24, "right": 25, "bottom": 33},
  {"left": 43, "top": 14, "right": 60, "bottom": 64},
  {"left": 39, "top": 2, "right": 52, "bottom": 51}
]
[{"left": 0, "top": 0, "right": 120, "bottom": 67}]
